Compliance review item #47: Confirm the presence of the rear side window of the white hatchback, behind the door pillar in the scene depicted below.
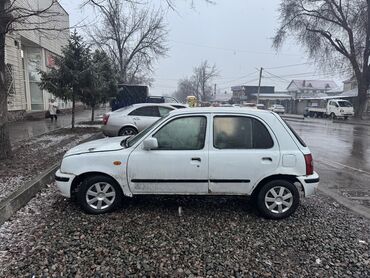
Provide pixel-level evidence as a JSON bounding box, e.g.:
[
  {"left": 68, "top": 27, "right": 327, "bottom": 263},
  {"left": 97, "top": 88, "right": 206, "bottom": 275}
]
[{"left": 213, "top": 116, "right": 274, "bottom": 149}]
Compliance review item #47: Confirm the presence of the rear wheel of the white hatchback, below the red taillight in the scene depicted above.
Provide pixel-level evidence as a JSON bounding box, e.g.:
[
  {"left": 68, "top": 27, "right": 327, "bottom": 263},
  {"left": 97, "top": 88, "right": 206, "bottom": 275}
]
[{"left": 256, "top": 180, "right": 299, "bottom": 220}]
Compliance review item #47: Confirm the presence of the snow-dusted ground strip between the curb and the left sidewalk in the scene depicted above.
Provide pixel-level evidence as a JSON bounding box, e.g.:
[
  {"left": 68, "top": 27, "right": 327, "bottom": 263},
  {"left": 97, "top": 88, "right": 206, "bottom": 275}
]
[{"left": 0, "top": 127, "right": 99, "bottom": 201}]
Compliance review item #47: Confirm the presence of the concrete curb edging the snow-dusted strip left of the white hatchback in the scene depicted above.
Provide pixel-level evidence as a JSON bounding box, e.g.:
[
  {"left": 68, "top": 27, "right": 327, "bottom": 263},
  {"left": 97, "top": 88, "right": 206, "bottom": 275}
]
[{"left": 0, "top": 132, "right": 102, "bottom": 225}]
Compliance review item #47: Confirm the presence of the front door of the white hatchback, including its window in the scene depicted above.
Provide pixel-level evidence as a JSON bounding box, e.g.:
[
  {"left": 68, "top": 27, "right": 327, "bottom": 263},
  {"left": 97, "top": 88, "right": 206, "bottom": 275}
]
[{"left": 127, "top": 116, "right": 208, "bottom": 194}]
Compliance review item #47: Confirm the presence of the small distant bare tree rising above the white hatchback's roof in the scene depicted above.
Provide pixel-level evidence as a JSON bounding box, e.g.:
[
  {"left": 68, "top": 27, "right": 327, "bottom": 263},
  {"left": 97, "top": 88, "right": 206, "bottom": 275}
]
[{"left": 193, "top": 60, "right": 218, "bottom": 101}]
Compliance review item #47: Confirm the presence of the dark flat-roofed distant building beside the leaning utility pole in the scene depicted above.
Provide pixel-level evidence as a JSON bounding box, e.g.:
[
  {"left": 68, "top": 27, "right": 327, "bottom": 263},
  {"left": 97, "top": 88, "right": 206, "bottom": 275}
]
[{"left": 231, "top": 85, "right": 275, "bottom": 103}]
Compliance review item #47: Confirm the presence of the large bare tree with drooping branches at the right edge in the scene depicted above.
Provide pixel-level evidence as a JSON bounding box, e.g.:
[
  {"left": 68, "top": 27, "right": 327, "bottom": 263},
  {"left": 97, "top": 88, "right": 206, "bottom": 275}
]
[{"left": 273, "top": 0, "right": 370, "bottom": 118}]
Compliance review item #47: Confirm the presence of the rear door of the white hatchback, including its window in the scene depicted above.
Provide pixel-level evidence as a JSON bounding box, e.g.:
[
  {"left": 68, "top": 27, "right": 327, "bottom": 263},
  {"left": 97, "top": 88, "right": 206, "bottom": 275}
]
[{"left": 209, "top": 115, "right": 280, "bottom": 194}]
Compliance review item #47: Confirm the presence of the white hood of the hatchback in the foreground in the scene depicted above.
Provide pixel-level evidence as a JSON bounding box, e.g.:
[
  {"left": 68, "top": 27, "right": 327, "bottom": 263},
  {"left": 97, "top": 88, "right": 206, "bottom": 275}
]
[{"left": 64, "top": 136, "right": 129, "bottom": 157}]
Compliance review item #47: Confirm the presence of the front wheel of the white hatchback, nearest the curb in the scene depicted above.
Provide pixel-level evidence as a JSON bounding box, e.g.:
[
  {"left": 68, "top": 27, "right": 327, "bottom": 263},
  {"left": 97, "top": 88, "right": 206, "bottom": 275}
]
[{"left": 77, "top": 175, "right": 123, "bottom": 214}]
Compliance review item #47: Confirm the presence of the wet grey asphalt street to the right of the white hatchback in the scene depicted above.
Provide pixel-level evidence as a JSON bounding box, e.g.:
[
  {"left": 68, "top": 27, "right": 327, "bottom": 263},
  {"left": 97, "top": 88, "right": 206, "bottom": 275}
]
[{"left": 289, "top": 119, "right": 370, "bottom": 212}]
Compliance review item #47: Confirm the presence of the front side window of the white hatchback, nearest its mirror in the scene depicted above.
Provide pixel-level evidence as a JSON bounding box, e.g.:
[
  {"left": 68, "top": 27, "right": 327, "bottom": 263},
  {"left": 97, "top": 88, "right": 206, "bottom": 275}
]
[{"left": 153, "top": 116, "right": 207, "bottom": 150}]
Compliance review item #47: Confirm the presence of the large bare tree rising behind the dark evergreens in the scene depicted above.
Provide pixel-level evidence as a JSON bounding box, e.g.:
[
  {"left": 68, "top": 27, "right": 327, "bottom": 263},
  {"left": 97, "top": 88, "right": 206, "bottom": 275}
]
[{"left": 89, "top": 0, "right": 168, "bottom": 83}]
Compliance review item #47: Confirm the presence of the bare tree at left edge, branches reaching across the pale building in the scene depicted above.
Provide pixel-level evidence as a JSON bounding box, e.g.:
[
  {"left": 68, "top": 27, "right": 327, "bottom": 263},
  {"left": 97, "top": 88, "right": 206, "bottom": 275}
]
[{"left": 0, "top": 0, "right": 67, "bottom": 159}]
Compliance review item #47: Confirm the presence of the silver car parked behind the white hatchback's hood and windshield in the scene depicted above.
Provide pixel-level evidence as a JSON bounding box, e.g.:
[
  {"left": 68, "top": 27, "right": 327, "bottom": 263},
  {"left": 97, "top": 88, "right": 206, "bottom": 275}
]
[{"left": 102, "top": 103, "right": 176, "bottom": 136}]
